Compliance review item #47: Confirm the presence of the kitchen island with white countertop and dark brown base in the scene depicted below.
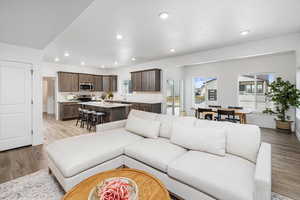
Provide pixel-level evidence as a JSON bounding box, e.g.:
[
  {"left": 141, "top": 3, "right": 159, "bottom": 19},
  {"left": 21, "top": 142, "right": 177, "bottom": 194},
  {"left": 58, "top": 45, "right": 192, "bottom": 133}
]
[{"left": 78, "top": 102, "right": 131, "bottom": 122}]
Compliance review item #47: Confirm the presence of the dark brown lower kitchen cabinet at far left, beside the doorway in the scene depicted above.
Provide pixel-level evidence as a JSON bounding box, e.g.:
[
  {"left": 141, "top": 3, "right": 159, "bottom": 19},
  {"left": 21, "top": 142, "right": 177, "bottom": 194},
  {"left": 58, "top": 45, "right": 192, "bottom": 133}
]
[{"left": 59, "top": 103, "right": 80, "bottom": 120}]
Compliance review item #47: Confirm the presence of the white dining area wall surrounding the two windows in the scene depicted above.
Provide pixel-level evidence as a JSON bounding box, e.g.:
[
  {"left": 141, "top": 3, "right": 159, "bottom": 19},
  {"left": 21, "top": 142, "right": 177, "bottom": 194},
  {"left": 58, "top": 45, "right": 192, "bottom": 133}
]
[{"left": 184, "top": 51, "right": 296, "bottom": 128}]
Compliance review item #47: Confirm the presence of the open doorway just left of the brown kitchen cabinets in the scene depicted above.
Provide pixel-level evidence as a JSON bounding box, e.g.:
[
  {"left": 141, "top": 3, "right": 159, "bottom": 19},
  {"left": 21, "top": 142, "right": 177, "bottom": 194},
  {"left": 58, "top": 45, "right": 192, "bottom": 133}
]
[{"left": 43, "top": 77, "right": 56, "bottom": 118}]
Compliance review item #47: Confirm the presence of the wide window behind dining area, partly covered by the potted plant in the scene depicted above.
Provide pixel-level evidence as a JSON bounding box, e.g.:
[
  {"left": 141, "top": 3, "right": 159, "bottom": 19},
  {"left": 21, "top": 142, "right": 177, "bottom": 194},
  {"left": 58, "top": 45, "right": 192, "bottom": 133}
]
[{"left": 238, "top": 73, "right": 274, "bottom": 112}]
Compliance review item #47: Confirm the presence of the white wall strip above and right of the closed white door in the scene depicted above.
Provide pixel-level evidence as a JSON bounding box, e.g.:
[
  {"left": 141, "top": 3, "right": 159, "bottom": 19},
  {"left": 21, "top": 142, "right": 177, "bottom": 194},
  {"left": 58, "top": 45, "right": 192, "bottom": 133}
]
[{"left": 0, "top": 43, "right": 43, "bottom": 145}]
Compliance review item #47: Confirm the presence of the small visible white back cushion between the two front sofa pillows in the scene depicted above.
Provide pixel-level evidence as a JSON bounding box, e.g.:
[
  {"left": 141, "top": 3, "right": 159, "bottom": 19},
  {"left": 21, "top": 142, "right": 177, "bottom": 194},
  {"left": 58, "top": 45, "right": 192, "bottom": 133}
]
[{"left": 158, "top": 115, "right": 178, "bottom": 139}]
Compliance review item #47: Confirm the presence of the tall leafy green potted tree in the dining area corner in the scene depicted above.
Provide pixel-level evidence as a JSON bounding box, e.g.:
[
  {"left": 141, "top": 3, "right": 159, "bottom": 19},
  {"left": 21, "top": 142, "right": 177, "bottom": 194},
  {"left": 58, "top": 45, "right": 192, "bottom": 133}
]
[{"left": 263, "top": 77, "right": 300, "bottom": 132}]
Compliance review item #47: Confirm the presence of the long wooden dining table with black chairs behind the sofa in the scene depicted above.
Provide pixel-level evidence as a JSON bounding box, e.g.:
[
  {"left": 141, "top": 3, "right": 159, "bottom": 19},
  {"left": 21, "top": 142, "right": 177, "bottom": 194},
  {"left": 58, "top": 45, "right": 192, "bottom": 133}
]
[{"left": 192, "top": 107, "right": 252, "bottom": 124}]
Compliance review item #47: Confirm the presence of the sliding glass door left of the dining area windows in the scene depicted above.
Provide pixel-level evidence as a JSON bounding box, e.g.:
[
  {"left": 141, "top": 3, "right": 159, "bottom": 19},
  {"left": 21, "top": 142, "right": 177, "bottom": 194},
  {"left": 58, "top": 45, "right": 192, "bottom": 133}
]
[{"left": 166, "top": 80, "right": 184, "bottom": 116}]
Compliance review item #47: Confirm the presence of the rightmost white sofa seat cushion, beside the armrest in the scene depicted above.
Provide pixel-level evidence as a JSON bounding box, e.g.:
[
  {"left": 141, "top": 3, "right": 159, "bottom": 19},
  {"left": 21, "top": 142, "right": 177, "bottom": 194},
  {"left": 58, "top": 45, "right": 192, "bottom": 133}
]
[{"left": 168, "top": 151, "right": 255, "bottom": 200}]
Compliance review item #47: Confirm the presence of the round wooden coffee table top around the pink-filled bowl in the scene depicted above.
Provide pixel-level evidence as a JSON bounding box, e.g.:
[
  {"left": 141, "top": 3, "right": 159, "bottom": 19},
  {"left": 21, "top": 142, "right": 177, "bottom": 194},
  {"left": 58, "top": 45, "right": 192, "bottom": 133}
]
[{"left": 63, "top": 168, "right": 171, "bottom": 200}]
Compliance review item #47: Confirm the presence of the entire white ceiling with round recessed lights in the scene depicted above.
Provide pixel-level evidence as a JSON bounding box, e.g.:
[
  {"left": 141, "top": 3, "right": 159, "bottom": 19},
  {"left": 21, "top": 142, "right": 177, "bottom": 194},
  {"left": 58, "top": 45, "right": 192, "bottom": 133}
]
[{"left": 0, "top": 0, "right": 300, "bottom": 67}]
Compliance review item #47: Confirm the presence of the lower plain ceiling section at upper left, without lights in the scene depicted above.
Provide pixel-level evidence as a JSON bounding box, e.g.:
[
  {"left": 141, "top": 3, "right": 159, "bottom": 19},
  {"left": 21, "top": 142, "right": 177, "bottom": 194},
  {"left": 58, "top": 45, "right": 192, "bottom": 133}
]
[{"left": 0, "top": 0, "right": 93, "bottom": 49}]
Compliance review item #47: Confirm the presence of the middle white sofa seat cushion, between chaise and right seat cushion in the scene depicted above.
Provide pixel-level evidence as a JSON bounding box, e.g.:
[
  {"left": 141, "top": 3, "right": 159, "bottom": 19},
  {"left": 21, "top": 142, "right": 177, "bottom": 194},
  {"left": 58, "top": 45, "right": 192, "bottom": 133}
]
[{"left": 125, "top": 138, "right": 187, "bottom": 172}]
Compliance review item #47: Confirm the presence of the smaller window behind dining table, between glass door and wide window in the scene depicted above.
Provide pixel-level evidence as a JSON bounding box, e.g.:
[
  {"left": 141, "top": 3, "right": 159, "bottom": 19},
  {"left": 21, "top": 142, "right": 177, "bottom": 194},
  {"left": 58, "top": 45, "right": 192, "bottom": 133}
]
[{"left": 193, "top": 77, "right": 218, "bottom": 107}]
